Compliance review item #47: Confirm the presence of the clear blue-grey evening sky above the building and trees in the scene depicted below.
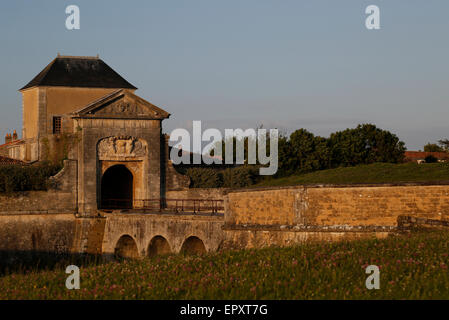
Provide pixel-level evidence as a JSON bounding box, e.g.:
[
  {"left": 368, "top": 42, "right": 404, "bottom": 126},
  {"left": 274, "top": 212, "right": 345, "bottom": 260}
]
[{"left": 0, "top": 0, "right": 449, "bottom": 150}]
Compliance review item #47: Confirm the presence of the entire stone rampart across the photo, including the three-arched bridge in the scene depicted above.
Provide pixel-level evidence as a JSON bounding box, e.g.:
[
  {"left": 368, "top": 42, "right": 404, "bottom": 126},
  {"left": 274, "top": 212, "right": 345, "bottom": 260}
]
[{"left": 0, "top": 180, "right": 449, "bottom": 256}]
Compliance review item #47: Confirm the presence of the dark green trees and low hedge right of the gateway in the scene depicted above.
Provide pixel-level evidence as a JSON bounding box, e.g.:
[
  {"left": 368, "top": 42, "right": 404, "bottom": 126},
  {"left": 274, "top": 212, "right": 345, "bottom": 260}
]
[{"left": 179, "top": 124, "right": 406, "bottom": 188}]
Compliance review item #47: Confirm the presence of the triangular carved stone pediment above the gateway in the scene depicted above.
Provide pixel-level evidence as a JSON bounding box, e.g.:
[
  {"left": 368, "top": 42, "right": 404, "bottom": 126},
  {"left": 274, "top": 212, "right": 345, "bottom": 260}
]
[{"left": 73, "top": 90, "right": 170, "bottom": 119}]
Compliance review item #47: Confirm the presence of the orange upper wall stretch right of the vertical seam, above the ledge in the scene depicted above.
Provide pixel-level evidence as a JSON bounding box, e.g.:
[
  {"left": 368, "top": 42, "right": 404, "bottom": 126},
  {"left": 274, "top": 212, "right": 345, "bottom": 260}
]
[{"left": 303, "top": 185, "right": 449, "bottom": 226}]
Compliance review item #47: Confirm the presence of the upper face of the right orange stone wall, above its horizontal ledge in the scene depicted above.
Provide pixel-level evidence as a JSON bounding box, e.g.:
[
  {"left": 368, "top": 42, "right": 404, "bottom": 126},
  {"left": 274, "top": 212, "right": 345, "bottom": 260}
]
[{"left": 225, "top": 185, "right": 449, "bottom": 227}]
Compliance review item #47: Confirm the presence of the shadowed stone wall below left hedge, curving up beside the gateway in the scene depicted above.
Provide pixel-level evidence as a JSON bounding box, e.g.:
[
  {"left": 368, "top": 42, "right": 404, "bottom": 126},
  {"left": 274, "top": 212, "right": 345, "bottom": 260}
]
[{"left": 0, "top": 160, "right": 76, "bottom": 215}]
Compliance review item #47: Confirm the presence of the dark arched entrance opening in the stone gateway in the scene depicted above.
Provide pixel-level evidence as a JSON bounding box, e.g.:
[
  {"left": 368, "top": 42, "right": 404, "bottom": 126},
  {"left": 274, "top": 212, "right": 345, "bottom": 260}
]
[{"left": 101, "top": 164, "right": 133, "bottom": 209}]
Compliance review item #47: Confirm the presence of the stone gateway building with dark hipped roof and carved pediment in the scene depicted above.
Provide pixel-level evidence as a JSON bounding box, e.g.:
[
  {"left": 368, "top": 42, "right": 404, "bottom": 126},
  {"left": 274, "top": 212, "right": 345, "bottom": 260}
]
[{"left": 3, "top": 55, "right": 189, "bottom": 215}]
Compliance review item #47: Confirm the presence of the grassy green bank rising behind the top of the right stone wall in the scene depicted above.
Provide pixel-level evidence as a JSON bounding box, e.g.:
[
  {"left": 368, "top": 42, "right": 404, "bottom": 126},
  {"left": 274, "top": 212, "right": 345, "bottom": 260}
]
[{"left": 255, "top": 163, "right": 449, "bottom": 186}]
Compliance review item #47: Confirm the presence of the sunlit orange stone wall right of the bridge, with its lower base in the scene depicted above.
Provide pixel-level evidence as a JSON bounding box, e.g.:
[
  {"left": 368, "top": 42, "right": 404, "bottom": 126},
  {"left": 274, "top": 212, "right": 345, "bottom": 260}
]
[{"left": 223, "top": 184, "right": 449, "bottom": 248}]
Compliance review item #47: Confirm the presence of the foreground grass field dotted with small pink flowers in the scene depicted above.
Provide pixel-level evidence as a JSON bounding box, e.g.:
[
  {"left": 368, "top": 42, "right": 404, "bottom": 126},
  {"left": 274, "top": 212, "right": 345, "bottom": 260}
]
[{"left": 0, "top": 231, "right": 449, "bottom": 299}]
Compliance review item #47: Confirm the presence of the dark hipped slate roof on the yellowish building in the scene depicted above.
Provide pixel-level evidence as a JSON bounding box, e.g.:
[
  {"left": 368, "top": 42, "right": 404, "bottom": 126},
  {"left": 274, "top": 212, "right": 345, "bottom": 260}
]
[{"left": 20, "top": 56, "right": 137, "bottom": 90}]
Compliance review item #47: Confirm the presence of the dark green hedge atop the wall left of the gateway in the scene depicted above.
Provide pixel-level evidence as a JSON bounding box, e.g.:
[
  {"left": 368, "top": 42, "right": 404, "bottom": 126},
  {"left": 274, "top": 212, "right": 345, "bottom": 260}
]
[{"left": 0, "top": 162, "right": 62, "bottom": 193}]
